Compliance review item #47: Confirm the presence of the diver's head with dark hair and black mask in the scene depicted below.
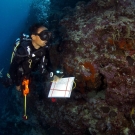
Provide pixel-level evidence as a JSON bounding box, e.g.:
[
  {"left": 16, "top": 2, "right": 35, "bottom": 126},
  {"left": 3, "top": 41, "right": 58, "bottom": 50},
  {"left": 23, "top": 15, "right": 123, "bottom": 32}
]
[{"left": 30, "top": 24, "right": 51, "bottom": 49}]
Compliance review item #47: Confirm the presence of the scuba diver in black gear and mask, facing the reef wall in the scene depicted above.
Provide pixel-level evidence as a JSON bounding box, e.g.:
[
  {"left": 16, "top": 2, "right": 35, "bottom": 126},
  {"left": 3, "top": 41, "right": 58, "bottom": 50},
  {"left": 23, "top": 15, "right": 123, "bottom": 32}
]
[{"left": 0, "top": 24, "right": 58, "bottom": 91}]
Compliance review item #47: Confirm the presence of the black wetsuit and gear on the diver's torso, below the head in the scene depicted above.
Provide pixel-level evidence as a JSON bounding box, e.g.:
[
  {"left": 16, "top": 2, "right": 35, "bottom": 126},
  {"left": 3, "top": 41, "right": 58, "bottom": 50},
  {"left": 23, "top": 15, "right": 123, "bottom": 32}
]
[{"left": 9, "top": 40, "right": 52, "bottom": 86}]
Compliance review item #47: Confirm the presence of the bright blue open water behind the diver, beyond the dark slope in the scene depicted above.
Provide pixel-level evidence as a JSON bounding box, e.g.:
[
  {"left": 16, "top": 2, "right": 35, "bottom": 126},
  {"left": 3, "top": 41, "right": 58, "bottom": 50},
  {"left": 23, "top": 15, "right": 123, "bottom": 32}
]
[{"left": 0, "top": 0, "right": 32, "bottom": 72}]
